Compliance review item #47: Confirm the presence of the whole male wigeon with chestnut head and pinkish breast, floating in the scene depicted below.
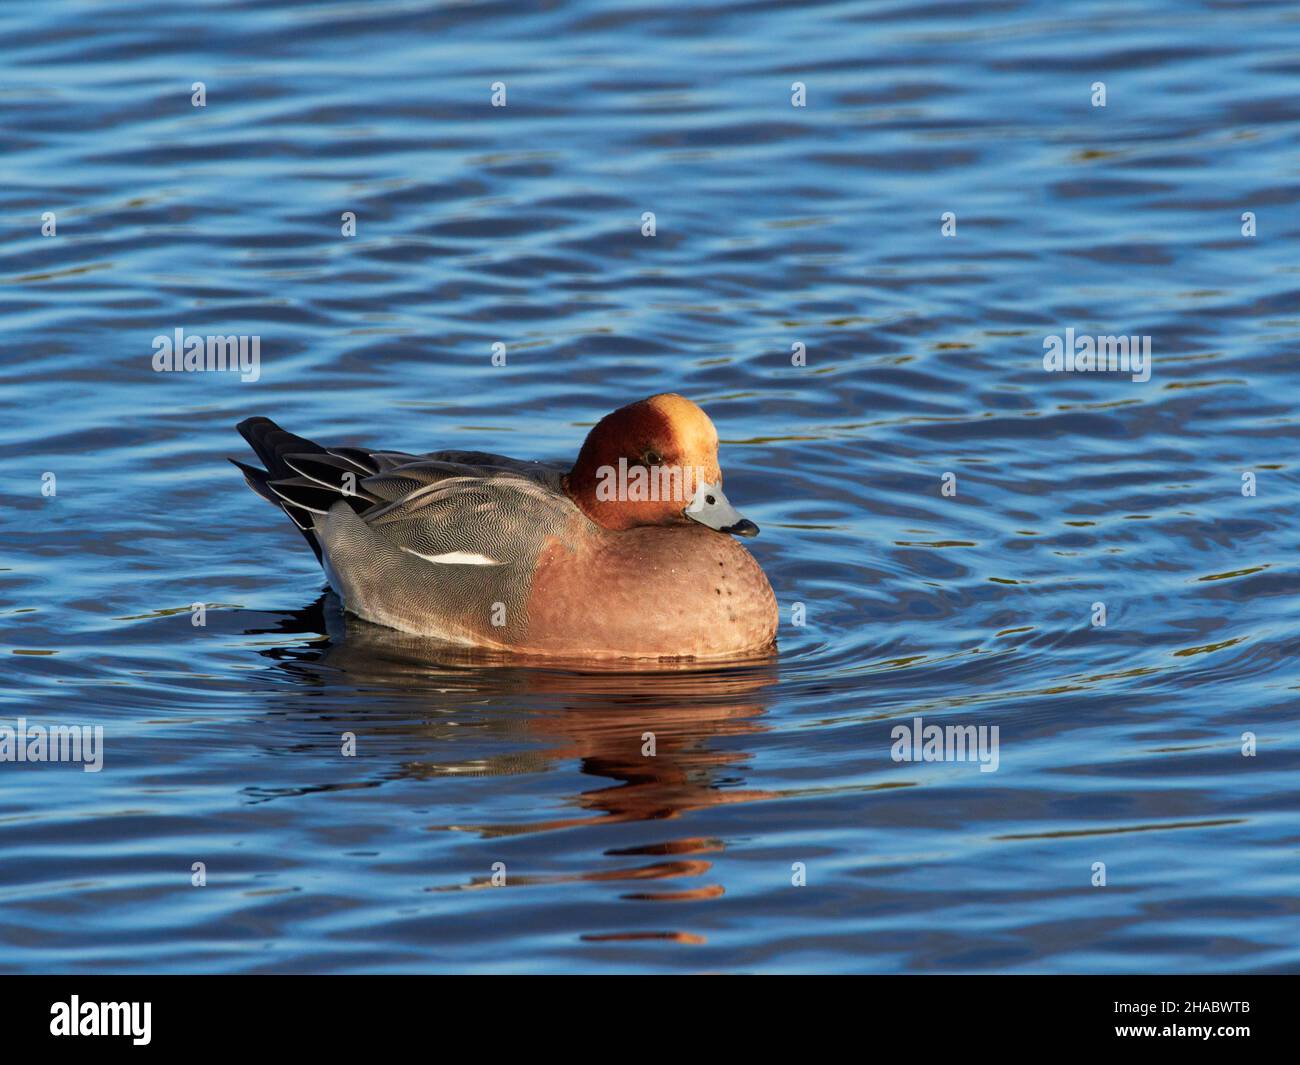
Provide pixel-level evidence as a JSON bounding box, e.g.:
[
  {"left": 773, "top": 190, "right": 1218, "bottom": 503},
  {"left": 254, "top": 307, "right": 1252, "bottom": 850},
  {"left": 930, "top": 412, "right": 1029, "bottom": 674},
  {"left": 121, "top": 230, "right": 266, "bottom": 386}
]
[{"left": 231, "top": 393, "right": 777, "bottom": 658}]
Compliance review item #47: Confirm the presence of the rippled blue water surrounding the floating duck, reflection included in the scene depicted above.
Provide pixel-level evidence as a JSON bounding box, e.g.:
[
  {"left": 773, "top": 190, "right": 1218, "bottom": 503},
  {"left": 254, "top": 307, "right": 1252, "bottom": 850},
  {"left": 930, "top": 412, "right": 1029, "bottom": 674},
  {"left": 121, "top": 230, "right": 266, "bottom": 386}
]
[{"left": 0, "top": 0, "right": 1300, "bottom": 973}]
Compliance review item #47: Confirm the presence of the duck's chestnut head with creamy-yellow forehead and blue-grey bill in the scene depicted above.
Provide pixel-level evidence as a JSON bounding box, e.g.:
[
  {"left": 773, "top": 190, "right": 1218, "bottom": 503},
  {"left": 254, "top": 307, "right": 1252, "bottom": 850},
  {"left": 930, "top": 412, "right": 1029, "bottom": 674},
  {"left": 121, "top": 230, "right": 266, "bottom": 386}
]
[{"left": 564, "top": 393, "right": 758, "bottom": 536}]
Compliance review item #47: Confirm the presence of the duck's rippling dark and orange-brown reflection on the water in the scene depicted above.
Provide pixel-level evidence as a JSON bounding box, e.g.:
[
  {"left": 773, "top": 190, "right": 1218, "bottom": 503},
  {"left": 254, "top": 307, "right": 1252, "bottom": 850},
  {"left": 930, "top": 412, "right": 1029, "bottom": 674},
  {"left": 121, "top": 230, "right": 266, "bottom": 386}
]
[{"left": 247, "top": 593, "right": 777, "bottom": 900}]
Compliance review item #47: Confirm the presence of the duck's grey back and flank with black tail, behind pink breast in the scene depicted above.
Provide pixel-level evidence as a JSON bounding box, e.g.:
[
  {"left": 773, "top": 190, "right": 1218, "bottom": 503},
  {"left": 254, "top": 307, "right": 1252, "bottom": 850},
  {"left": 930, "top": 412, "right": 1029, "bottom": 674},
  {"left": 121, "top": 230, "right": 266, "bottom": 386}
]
[{"left": 235, "top": 417, "right": 580, "bottom": 644}]
